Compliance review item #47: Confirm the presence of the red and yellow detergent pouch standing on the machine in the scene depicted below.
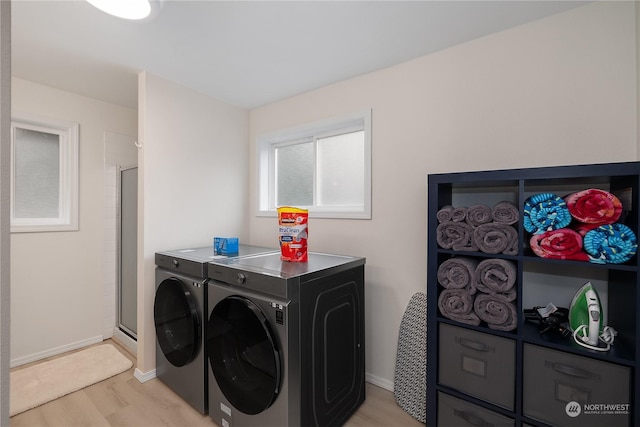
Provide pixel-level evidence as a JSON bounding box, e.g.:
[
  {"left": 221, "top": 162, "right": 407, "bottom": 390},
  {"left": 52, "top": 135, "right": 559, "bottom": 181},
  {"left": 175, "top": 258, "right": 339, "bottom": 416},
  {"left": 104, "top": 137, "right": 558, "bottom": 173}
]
[{"left": 278, "top": 206, "right": 309, "bottom": 262}]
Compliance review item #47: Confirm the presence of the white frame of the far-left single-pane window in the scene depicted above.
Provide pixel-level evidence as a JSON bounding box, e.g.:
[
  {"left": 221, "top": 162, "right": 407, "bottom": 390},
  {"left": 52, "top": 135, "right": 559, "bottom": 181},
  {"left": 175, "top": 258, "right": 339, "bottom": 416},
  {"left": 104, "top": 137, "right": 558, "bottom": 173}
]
[{"left": 10, "top": 114, "right": 79, "bottom": 233}]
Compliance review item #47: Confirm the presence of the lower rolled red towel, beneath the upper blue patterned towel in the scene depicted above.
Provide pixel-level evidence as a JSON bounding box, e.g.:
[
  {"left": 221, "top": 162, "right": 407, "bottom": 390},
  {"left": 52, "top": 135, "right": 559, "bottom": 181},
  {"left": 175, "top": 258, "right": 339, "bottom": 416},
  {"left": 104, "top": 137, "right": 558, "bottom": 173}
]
[{"left": 529, "top": 228, "right": 589, "bottom": 261}]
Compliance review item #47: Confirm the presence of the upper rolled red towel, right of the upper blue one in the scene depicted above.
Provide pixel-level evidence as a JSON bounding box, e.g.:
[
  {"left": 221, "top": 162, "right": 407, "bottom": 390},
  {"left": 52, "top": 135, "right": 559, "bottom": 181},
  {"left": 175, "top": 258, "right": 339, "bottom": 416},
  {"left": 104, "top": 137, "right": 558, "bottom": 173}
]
[{"left": 564, "top": 188, "right": 622, "bottom": 225}]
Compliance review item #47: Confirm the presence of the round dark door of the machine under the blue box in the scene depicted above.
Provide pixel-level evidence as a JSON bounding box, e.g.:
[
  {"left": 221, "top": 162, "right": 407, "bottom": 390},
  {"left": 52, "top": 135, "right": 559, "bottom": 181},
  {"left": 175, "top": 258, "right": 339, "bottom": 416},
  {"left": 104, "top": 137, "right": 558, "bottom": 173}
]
[{"left": 153, "top": 277, "right": 202, "bottom": 367}]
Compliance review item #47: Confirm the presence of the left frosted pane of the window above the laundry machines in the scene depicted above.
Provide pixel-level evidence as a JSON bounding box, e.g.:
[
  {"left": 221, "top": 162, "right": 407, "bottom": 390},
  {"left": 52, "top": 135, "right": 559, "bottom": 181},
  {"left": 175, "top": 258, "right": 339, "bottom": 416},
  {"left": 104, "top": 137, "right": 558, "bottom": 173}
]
[{"left": 275, "top": 142, "right": 314, "bottom": 206}]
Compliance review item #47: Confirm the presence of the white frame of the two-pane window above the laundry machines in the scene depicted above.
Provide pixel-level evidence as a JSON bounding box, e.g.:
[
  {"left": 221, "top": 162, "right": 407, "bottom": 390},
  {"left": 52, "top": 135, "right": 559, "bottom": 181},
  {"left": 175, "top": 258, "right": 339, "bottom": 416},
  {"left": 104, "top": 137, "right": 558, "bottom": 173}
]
[{"left": 256, "top": 109, "right": 371, "bottom": 219}]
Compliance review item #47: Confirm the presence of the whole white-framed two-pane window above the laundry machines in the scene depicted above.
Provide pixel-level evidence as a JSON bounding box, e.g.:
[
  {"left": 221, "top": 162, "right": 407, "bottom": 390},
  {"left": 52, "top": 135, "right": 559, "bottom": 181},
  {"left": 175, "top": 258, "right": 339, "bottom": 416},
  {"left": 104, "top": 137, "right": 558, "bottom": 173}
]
[{"left": 257, "top": 110, "right": 371, "bottom": 219}]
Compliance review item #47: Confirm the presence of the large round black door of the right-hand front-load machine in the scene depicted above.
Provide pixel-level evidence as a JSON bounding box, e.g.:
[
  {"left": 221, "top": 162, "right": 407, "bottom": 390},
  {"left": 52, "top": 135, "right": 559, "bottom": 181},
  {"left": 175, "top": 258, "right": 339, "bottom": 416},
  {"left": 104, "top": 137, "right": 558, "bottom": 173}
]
[{"left": 207, "top": 296, "right": 282, "bottom": 415}]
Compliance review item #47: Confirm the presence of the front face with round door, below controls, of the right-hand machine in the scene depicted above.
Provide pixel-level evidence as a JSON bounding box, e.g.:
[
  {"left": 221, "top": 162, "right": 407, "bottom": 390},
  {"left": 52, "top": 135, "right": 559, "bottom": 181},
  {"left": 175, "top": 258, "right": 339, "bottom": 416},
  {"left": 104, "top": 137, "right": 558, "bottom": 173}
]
[{"left": 207, "top": 281, "right": 290, "bottom": 427}]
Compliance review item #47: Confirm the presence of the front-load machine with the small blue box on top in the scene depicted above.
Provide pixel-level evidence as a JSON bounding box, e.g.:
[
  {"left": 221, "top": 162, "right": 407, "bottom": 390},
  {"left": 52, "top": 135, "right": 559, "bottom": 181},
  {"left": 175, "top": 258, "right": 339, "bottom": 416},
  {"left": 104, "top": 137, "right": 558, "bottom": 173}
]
[{"left": 153, "top": 245, "right": 274, "bottom": 414}]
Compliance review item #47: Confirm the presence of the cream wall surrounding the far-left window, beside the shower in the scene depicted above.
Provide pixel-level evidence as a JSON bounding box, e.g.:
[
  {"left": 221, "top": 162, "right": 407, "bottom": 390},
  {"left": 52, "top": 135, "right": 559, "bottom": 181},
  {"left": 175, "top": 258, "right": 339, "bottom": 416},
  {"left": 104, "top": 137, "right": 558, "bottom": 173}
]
[{"left": 11, "top": 78, "right": 137, "bottom": 365}]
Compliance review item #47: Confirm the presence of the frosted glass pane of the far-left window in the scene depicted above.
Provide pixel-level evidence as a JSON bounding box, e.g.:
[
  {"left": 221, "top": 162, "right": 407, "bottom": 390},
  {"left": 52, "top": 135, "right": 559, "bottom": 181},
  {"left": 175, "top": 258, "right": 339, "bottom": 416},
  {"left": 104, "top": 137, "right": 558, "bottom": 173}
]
[{"left": 14, "top": 128, "right": 60, "bottom": 218}]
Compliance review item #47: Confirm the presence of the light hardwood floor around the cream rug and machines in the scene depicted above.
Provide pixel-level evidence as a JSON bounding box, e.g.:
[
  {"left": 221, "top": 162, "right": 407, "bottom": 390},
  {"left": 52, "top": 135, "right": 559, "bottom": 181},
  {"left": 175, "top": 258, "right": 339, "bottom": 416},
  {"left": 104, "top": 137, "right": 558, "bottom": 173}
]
[{"left": 10, "top": 340, "right": 424, "bottom": 427}]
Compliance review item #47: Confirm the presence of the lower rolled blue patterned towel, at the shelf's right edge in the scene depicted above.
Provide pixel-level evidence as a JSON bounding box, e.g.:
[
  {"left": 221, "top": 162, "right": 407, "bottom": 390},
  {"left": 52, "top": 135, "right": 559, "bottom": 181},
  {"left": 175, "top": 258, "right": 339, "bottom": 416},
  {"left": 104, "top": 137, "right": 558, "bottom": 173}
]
[{"left": 582, "top": 223, "right": 638, "bottom": 264}]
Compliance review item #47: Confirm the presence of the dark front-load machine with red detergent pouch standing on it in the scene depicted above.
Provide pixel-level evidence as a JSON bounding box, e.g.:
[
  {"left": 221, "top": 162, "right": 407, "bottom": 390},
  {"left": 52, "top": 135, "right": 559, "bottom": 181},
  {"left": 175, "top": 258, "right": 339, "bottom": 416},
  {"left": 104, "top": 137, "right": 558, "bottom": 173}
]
[{"left": 207, "top": 253, "right": 365, "bottom": 427}]
